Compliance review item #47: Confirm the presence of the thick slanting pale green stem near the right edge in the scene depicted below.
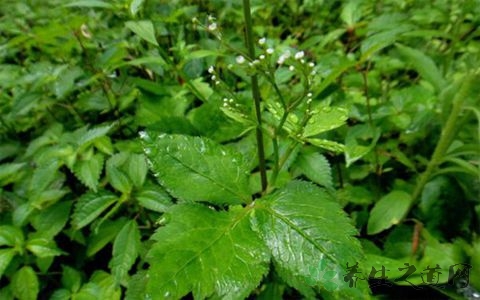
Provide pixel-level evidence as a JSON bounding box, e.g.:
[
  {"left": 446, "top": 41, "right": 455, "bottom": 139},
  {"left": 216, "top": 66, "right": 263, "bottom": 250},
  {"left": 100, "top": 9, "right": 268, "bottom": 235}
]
[{"left": 410, "top": 76, "right": 474, "bottom": 209}]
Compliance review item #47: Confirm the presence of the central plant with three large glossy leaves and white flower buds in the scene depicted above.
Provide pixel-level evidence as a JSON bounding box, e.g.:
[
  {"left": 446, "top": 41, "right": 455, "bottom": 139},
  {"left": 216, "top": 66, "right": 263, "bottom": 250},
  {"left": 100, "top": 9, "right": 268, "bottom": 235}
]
[{"left": 135, "top": 0, "right": 368, "bottom": 299}]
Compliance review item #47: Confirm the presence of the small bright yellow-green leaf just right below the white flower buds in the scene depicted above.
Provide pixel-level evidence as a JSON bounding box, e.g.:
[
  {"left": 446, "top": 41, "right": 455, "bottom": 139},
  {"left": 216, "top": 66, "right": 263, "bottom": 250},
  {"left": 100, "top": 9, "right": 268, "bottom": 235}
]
[{"left": 303, "top": 105, "right": 348, "bottom": 137}]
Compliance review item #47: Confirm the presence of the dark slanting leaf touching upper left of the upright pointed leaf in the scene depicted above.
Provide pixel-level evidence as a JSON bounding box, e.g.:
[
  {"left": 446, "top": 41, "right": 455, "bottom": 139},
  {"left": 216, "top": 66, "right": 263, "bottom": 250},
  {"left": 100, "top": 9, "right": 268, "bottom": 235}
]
[{"left": 87, "top": 219, "right": 125, "bottom": 256}]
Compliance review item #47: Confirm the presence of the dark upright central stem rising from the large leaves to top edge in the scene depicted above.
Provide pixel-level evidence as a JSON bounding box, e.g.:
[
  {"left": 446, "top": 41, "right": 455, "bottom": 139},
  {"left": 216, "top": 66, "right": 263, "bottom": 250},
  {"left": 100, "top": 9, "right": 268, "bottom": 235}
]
[{"left": 243, "top": 0, "right": 268, "bottom": 193}]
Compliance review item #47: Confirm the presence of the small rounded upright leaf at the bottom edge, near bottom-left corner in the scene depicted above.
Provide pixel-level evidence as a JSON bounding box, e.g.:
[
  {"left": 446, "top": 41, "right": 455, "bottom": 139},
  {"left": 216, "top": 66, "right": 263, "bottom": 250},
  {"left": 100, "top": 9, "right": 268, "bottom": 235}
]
[{"left": 11, "top": 266, "right": 40, "bottom": 300}]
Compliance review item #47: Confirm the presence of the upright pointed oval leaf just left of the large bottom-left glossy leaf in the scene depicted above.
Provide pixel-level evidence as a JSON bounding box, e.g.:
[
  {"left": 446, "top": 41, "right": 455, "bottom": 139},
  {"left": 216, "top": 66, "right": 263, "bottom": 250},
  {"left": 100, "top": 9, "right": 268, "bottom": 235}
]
[{"left": 109, "top": 220, "right": 140, "bottom": 283}]
